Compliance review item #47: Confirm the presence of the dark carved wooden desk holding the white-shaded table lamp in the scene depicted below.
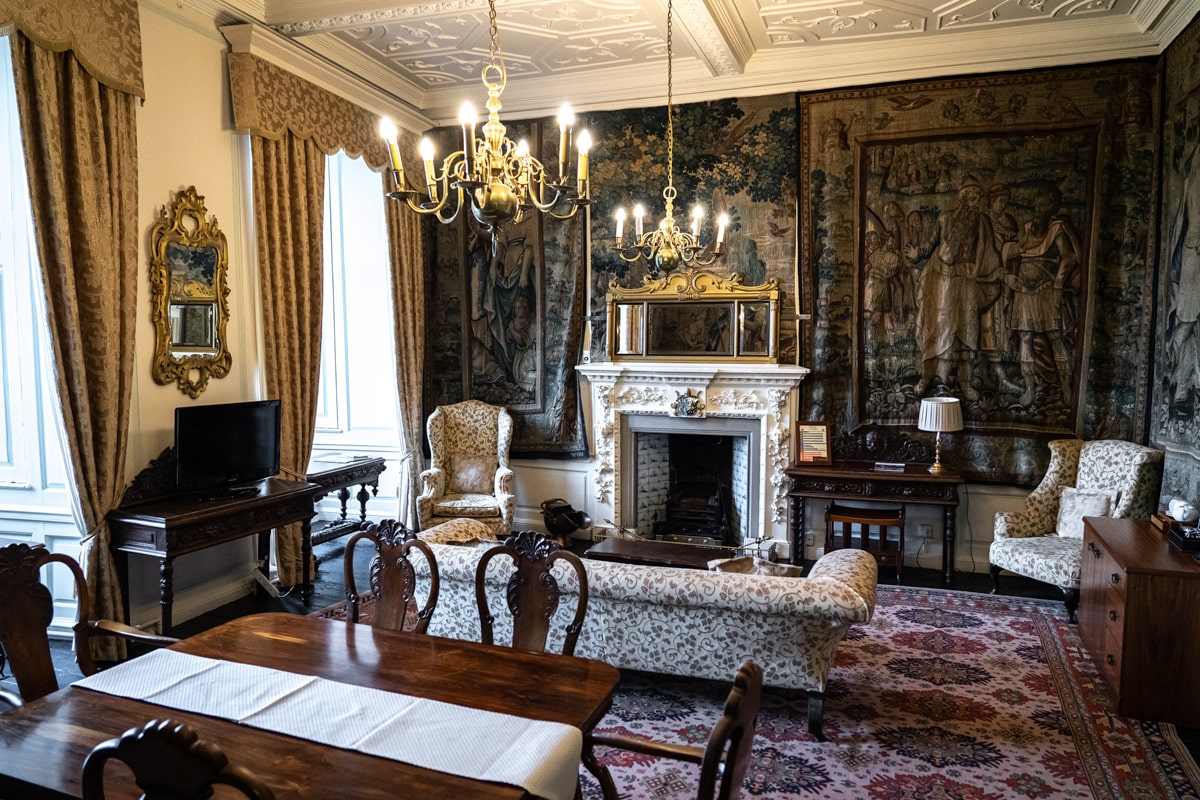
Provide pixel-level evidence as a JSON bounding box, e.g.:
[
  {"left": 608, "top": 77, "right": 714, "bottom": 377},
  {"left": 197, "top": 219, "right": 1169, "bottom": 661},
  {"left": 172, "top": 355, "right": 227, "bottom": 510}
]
[{"left": 784, "top": 461, "right": 962, "bottom": 587}]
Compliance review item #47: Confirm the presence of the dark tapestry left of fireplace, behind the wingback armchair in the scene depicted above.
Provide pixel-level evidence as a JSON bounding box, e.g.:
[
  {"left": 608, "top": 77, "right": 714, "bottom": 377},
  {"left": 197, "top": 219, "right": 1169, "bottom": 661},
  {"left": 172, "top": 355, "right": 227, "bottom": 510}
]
[{"left": 425, "top": 115, "right": 587, "bottom": 458}]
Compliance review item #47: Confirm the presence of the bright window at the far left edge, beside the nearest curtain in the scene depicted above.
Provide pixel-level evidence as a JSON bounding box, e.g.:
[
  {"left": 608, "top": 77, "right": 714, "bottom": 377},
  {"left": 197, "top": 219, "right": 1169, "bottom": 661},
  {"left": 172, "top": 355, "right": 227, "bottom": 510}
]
[{"left": 0, "top": 37, "right": 79, "bottom": 628}]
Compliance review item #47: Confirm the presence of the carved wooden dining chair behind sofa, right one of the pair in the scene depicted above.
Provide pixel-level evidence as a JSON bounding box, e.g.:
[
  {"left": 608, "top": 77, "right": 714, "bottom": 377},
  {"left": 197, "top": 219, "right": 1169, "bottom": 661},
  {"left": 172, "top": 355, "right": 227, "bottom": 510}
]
[{"left": 475, "top": 530, "right": 588, "bottom": 656}]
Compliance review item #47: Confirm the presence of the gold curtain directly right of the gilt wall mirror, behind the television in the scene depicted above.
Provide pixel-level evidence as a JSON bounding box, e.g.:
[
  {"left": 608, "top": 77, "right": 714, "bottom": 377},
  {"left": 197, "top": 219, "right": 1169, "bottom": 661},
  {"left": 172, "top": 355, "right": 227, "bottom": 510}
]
[{"left": 250, "top": 132, "right": 325, "bottom": 585}]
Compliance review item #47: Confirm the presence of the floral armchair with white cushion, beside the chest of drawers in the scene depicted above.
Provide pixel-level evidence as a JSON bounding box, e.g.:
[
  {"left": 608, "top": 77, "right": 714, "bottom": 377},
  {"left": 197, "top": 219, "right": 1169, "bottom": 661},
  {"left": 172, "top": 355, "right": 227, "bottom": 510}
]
[{"left": 988, "top": 439, "right": 1163, "bottom": 622}]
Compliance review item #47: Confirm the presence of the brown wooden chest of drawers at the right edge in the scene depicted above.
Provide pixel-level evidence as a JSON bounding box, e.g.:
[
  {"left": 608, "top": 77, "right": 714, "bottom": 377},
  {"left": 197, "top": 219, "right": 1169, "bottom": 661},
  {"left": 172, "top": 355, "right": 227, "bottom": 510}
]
[{"left": 1079, "top": 517, "right": 1200, "bottom": 727}]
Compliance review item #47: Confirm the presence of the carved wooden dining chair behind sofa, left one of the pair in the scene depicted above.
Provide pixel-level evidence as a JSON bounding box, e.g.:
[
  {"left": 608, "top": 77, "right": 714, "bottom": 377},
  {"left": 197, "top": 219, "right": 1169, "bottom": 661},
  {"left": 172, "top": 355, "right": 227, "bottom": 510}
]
[{"left": 344, "top": 519, "right": 440, "bottom": 633}]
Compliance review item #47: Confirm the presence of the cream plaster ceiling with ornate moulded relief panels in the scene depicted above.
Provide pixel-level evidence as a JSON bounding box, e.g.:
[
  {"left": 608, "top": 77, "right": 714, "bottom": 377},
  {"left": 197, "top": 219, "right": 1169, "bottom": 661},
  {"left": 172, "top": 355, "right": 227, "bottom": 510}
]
[{"left": 230, "top": 0, "right": 1200, "bottom": 121}]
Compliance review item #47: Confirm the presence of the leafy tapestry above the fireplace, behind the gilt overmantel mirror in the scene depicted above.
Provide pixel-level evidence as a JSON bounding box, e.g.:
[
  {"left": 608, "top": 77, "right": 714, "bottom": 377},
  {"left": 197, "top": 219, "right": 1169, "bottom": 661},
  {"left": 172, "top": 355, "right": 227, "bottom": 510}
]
[{"left": 588, "top": 94, "right": 799, "bottom": 363}]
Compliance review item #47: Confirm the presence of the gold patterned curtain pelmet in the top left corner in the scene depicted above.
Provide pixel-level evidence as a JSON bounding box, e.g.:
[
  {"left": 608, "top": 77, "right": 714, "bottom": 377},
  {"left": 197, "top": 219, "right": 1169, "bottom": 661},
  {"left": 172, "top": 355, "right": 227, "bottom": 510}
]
[{"left": 0, "top": 0, "right": 145, "bottom": 98}]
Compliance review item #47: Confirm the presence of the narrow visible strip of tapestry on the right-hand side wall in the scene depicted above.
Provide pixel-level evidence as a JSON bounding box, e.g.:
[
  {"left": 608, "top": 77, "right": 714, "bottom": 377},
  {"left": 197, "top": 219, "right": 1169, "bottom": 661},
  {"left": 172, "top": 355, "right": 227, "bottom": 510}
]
[{"left": 1150, "top": 14, "right": 1200, "bottom": 503}]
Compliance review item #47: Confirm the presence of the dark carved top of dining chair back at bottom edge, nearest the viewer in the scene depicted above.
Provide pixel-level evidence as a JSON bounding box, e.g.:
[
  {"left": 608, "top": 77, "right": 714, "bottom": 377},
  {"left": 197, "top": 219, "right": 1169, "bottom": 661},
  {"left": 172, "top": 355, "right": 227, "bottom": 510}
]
[{"left": 83, "top": 720, "right": 275, "bottom": 800}]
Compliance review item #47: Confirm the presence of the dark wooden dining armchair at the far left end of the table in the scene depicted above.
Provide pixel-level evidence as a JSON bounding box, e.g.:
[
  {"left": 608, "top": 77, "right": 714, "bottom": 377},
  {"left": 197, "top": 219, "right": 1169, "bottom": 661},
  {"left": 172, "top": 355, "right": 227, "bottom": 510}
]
[{"left": 0, "top": 542, "right": 179, "bottom": 704}]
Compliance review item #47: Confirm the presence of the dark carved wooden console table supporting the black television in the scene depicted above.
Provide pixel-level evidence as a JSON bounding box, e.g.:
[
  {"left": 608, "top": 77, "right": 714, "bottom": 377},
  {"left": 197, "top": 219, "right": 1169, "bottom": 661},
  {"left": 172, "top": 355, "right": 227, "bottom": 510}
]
[{"left": 108, "top": 477, "right": 325, "bottom": 634}]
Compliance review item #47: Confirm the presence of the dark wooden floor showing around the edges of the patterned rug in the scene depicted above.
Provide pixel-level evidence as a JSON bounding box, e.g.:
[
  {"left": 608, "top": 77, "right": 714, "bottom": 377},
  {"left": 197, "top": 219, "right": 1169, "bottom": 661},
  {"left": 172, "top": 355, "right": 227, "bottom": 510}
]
[{"left": 0, "top": 537, "right": 1200, "bottom": 762}]
